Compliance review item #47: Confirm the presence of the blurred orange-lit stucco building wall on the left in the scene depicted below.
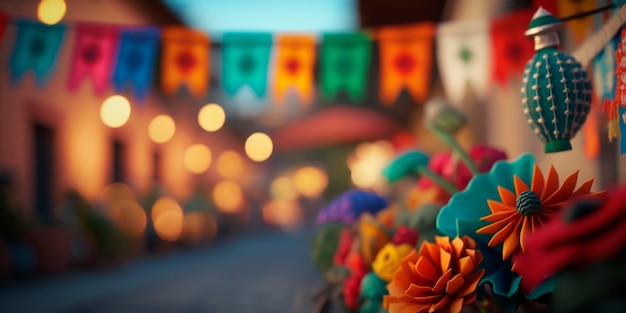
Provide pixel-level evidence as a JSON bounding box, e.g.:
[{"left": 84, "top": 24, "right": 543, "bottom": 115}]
[{"left": 0, "top": 0, "right": 249, "bottom": 215}]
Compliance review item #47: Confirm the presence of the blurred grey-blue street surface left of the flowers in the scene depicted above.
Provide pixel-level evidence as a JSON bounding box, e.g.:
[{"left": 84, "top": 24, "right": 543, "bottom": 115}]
[{"left": 0, "top": 229, "right": 321, "bottom": 313}]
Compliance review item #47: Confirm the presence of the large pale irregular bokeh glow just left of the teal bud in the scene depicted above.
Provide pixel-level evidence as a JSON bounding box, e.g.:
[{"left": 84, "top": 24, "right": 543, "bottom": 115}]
[{"left": 348, "top": 140, "right": 395, "bottom": 190}]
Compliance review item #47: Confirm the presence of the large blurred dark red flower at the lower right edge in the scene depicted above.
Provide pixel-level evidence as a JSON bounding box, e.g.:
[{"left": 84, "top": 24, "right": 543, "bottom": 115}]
[{"left": 514, "top": 185, "right": 626, "bottom": 290}]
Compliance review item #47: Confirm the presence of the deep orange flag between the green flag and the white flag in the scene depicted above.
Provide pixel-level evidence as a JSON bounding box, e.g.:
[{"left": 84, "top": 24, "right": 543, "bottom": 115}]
[{"left": 377, "top": 23, "right": 435, "bottom": 106}]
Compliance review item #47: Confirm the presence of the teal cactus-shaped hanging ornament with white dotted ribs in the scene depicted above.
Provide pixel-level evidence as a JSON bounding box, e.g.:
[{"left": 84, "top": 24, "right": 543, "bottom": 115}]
[{"left": 521, "top": 7, "right": 591, "bottom": 153}]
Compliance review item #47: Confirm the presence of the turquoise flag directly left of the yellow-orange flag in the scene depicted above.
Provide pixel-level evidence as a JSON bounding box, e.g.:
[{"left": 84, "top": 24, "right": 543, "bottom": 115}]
[{"left": 222, "top": 33, "right": 272, "bottom": 97}]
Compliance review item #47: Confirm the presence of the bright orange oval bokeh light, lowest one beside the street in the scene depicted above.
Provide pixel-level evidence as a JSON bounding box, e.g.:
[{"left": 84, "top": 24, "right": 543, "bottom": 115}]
[{"left": 151, "top": 197, "right": 183, "bottom": 241}]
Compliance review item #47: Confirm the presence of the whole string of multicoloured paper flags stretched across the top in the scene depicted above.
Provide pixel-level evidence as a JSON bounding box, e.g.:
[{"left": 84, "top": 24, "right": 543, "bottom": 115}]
[{"left": 0, "top": 0, "right": 626, "bottom": 103}]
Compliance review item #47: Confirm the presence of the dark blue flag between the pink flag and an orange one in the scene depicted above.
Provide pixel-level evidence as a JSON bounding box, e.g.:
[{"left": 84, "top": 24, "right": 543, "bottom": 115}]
[{"left": 113, "top": 28, "right": 160, "bottom": 100}]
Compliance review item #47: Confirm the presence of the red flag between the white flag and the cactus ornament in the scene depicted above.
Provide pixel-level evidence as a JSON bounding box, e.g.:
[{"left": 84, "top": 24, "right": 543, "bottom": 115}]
[{"left": 490, "top": 9, "right": 535, "bottom": 86}]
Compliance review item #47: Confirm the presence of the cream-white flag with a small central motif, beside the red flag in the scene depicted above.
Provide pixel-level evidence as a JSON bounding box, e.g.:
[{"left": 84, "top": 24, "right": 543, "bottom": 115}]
[{"left": 437, "top": 20, "right": 491, "bottom": 105}]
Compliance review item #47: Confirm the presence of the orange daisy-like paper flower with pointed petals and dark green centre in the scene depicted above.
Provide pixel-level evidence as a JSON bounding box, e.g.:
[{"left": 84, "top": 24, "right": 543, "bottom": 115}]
[{"left": 476, "top": 164, "right": 604, "bottom": 267}]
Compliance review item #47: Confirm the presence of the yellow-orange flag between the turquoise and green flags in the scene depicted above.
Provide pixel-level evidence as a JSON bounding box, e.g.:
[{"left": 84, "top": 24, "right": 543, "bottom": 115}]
[{"left": 273, "top": 35, "right": 315, "bottom": 104}]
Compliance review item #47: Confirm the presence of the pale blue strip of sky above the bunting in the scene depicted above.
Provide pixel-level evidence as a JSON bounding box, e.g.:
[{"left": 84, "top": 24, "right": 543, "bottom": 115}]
[{"left": 163, "top": 0, "right": 358, "bottom": 35}]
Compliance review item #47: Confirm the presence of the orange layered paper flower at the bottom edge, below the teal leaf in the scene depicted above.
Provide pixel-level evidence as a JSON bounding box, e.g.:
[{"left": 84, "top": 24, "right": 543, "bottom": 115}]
[{"left": 383, "top": 236, "right": 485, "bottom": 313}]
